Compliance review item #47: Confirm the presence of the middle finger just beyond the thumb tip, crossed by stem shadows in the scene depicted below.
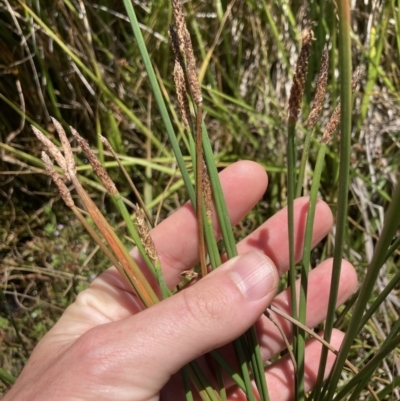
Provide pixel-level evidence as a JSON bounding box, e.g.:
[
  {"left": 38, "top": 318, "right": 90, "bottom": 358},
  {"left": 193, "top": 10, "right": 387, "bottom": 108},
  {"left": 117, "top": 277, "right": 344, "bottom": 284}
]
[{"left": 238, "top": 197, "right": 333, "bottom": 274}]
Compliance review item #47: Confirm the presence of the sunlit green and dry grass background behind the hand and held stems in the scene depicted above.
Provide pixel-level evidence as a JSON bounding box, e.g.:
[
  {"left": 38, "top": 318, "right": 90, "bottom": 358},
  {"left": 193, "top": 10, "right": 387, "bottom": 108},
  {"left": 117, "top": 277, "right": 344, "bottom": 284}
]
[{"left": 0, "top": 0, "right": 400, "bottom": 399}]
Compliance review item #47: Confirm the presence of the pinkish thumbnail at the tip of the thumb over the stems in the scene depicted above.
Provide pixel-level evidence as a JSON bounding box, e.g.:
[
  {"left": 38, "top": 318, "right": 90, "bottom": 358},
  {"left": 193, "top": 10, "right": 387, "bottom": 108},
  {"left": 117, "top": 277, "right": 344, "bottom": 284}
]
[{"left": 229, "top": 252, "right": 277, "bottom": 301}]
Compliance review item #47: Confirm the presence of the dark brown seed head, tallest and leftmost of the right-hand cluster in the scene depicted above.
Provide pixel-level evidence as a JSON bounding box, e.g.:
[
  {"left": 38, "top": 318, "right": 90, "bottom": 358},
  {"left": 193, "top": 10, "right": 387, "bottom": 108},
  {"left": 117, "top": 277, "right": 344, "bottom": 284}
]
[{"left": 289, "top": 27, "right": 314, "bottom": 123}]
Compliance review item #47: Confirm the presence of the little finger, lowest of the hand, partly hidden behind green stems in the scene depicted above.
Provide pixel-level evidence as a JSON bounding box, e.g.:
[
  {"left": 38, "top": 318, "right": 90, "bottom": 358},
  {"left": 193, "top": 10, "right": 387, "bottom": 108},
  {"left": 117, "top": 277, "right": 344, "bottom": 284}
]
[{"left": 228, "top": 330, "right": 344, "bottom": 401}]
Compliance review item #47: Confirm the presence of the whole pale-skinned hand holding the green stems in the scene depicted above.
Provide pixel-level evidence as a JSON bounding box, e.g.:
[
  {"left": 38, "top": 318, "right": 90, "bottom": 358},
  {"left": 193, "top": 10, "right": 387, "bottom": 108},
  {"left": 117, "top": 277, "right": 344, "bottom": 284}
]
[{"left": 4, "top": 161, "right": 357, "bottom": 401}]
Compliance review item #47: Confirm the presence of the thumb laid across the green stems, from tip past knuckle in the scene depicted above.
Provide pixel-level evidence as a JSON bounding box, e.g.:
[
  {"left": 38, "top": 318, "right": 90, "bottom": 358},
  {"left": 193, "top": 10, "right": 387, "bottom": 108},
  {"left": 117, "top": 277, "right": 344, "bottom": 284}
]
[{"left": 141, "top": 252, "right": 279, "bottom": 376}]
